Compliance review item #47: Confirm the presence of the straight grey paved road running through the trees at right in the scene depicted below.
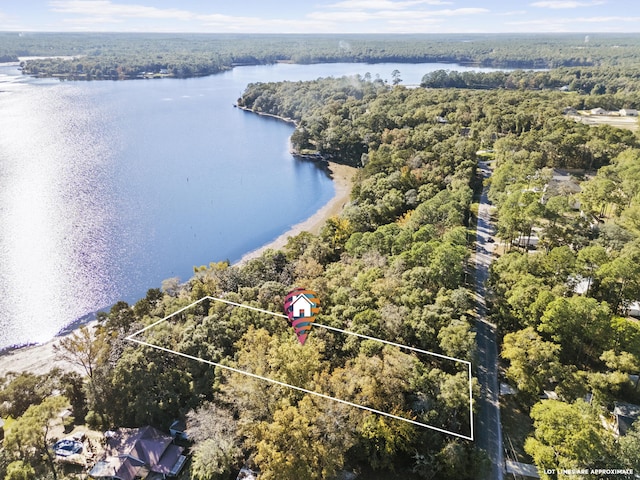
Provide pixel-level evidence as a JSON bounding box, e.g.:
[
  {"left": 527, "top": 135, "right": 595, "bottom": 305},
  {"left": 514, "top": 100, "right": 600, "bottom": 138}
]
[{"left": 475, "top": 162, "right": 504, "bottom": 480}]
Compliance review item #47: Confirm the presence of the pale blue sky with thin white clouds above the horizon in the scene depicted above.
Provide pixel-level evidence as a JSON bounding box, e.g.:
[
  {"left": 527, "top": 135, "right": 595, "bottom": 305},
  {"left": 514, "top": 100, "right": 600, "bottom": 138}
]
[{"left": 0, "top": 0, "right": 640, "bottom": 33}]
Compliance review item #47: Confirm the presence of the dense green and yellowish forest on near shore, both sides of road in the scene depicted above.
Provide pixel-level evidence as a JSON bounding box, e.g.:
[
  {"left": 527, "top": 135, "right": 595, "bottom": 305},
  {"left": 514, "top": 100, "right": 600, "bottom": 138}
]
[{"left": 0, "top": 35, "right": 640, "bottom": 480}]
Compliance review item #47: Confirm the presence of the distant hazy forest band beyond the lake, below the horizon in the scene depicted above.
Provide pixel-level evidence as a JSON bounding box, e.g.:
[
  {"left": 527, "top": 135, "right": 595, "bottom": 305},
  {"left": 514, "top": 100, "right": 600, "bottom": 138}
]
[{"left": 0, "top": 32, "right": 640, "bottom": 79}]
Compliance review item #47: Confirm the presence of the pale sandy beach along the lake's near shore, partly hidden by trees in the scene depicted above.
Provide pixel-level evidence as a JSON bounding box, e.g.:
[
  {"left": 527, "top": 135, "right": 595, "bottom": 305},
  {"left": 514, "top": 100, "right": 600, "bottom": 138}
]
[{"left": 0, "top": 162, "right": 357, "bottom": 378}]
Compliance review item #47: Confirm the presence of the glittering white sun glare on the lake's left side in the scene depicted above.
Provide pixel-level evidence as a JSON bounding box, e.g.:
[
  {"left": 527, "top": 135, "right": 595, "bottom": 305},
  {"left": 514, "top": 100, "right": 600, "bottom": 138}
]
[{"left": 0, "top": 80, "right": 113, "bottom": 347}]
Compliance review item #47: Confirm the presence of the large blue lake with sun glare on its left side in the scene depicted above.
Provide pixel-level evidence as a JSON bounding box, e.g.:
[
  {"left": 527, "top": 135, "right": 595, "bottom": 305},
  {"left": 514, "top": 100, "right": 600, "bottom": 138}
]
[{"left": 0, "top": 64, "right": 504, "bottom": 350}]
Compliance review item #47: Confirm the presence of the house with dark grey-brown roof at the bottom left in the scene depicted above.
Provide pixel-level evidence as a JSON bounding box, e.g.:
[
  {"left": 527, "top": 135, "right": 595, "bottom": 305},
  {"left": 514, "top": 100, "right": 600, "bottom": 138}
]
[{"left": 89, "top": 426, "right": 186, "bottom": 480}]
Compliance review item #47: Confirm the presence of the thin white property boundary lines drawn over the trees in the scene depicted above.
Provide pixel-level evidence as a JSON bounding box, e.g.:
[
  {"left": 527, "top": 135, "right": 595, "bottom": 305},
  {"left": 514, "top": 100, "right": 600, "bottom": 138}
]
[{"left": 125, "top": 296, "right": 474, "bottom": 441}]
